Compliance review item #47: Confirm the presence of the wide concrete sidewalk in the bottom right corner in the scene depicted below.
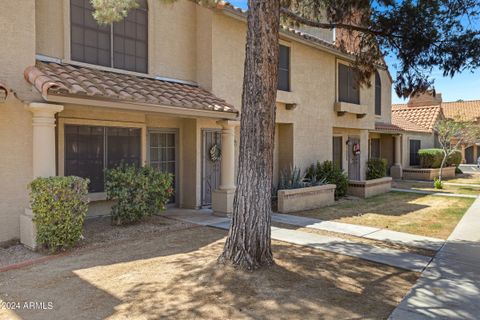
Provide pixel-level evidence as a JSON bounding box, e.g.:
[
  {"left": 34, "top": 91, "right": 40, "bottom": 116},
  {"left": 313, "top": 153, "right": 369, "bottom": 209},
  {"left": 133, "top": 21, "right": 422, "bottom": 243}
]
[{"left": 389, "top": 199, "right": 480, "bottom": 320}]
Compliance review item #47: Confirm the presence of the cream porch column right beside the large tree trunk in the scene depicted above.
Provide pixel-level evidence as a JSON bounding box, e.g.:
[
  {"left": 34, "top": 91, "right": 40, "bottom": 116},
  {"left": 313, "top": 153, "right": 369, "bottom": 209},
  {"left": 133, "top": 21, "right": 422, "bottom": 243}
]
[{"left": 212, "top": 120, "right": 239, "bottom": 216}]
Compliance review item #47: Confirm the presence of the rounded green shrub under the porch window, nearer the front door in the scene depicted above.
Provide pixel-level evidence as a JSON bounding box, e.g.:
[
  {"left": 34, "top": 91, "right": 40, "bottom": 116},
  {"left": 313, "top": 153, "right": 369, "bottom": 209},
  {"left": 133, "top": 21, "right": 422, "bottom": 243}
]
[{"left": 105, "top": 165, "right": 173, "bottom": 225}]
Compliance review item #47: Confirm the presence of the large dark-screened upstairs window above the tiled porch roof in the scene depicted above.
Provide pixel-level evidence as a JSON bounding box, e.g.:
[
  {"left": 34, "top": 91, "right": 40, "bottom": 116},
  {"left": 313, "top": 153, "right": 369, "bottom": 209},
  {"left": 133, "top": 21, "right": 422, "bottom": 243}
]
[{"left": 70, "top": 0, "right": 148, "bottom": 73}]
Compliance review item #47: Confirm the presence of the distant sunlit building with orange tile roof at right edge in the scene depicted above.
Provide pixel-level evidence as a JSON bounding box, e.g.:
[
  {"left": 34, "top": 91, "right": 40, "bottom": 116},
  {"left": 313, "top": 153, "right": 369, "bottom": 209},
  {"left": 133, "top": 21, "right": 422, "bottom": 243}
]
[{"left": 392, "top": 91, "right": 480, "bottom": 167}]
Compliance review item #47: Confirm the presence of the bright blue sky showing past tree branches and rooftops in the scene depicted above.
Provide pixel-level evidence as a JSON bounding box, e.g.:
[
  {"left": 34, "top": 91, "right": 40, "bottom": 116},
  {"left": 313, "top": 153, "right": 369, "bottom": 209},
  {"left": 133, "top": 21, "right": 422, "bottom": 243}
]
[{"left": 229, "top": 0, "right": 480, "bottom": 103}]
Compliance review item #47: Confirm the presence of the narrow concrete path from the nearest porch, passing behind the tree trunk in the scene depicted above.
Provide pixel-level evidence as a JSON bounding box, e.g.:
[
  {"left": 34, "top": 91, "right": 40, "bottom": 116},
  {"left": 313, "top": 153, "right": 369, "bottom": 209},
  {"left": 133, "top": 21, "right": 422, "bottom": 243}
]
[{"left": 166, "top": 210, "right": 432, "bottom": 272}]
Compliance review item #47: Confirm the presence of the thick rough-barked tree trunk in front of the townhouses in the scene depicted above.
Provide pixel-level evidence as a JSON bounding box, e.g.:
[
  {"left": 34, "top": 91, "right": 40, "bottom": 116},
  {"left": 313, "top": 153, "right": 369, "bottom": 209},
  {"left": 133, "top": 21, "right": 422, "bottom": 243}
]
[{"left": 219, "top": 0, "right": 280, "bottom": 270}]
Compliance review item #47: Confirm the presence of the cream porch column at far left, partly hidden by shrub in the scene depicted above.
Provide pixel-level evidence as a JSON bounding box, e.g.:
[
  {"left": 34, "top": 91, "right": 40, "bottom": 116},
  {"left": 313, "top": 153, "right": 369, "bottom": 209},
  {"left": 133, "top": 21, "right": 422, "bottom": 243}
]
[{"left": 20, "top": 102, "right": 63, "bottom": 249}]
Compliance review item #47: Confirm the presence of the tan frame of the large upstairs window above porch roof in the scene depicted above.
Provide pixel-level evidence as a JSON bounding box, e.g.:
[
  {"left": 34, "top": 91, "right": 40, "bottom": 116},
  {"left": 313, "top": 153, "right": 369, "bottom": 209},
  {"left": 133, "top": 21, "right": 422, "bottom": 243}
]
[{"left": 64, "top": 0, "right": 150, "bottom": 74}]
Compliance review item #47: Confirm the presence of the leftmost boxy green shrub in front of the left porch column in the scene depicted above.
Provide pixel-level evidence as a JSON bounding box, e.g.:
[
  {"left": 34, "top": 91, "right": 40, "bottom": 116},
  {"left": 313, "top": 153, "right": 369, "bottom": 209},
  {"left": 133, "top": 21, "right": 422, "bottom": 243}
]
[{"left": 29, "top": 177, "right": 89, "bottom": 252}]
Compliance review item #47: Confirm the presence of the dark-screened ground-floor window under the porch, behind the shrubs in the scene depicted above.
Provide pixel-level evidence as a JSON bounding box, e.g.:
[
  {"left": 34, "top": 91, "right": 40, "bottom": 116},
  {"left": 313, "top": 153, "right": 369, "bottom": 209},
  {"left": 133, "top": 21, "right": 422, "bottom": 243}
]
[{"left": 65, "top": 125, "right": 141, "bottom": 192}]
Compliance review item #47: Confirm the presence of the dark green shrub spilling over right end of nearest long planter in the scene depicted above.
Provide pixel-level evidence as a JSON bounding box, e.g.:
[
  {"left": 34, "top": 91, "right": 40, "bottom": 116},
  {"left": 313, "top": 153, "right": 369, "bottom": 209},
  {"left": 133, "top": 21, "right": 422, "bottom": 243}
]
[{"left": 305, "top": 160, "right": 348, "bottom": 199}]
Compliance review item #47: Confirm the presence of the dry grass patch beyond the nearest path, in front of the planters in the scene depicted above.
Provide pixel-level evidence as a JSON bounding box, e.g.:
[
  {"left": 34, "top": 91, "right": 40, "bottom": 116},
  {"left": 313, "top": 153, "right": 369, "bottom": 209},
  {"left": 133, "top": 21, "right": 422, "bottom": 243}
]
[{"left": 295, "top": 192, "right": 474, "bottom": 239}]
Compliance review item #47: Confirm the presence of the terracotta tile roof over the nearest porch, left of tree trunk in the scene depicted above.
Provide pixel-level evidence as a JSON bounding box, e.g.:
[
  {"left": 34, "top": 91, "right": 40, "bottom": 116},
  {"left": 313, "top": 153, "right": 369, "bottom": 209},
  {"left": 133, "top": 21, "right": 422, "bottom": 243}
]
[{"left": 24, "top": 61, "right": 237, "bottom": 113}]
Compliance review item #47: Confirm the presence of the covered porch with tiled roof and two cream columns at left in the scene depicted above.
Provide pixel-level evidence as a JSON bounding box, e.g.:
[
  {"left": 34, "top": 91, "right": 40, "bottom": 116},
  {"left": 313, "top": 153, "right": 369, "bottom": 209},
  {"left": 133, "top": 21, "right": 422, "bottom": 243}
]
[{"left": 20, "top": 62, "right": 239, "bottom": 246}]
